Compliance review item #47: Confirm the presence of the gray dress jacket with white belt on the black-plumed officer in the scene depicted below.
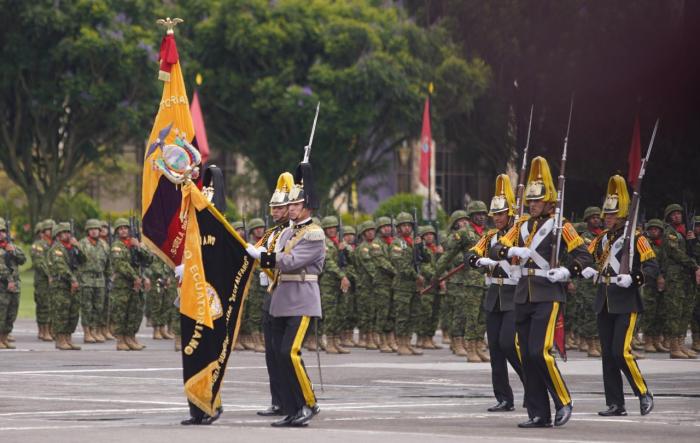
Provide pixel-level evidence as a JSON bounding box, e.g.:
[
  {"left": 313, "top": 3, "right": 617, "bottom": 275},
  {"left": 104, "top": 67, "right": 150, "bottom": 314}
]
[{"left": 260, "top": 220, "right": 326, "bottom": 317}]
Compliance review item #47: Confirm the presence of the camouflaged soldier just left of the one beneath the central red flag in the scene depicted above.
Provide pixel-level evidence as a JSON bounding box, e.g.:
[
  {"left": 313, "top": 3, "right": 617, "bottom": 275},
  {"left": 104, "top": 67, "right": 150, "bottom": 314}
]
[{"left": 389, "top": 212, "right": 425, "bottom": 355}]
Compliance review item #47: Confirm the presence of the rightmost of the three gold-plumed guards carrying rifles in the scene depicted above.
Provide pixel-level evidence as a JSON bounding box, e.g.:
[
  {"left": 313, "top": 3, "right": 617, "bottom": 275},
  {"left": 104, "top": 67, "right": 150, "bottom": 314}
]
[{"left": 582, "top": 175, "right": 659, "bottom": 417}]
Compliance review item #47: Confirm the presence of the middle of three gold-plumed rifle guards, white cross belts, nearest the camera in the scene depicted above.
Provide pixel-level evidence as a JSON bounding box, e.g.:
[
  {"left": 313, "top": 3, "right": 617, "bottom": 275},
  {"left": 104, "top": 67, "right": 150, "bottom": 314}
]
[{"left": 489, "top": 157, "right": 593, "bottom": 428}]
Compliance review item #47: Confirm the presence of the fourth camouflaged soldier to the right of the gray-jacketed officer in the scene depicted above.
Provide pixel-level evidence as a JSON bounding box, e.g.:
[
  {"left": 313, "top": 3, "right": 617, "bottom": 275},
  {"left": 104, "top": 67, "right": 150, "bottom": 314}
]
[{"left": 374, "top": 217, "right": 398, "bottom": 353}]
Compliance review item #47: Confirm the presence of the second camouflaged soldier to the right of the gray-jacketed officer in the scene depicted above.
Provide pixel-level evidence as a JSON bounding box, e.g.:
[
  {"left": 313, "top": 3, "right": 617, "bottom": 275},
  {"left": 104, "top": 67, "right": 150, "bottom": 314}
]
[{"left": 338, "top": 226, "right": 358, "bottom": 348}]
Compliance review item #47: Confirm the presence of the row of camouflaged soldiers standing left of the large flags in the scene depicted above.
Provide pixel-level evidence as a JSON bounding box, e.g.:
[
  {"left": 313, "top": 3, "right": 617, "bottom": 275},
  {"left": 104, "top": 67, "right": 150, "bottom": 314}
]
[{"left": 0, "top": 218, "right": 179, "bottom": 351}]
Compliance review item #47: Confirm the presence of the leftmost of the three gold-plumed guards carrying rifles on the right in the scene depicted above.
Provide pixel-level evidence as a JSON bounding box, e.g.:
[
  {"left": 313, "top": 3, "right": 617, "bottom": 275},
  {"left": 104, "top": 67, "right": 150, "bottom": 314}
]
[{"left": 469, "top": 174, "right": 524, "bottom": 412}]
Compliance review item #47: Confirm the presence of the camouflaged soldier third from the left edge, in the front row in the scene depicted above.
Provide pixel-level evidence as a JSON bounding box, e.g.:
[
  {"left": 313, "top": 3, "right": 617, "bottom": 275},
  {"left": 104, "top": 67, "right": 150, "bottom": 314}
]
[{"left": 47, "top": 223, "right": 86, "bottom": 351}]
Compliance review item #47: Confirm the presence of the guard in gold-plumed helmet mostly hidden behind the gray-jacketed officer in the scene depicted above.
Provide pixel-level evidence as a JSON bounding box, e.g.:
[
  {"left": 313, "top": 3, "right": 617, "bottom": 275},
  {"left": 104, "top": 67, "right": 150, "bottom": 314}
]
[{"left": 256, "top": 172, "right": 294, "bottom": 417}]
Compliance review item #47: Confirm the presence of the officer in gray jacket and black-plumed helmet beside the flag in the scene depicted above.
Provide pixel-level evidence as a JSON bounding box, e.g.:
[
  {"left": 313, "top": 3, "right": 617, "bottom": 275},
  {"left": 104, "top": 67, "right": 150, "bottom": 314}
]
[{"left": 247, "top": 163, "right": 326, "bottom": 427}]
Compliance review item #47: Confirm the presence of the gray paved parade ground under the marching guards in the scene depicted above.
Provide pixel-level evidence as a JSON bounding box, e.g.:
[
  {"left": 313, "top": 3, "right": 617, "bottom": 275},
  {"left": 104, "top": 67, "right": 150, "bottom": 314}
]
[{"left": 0, "top": 320, "right": 700, "bottom": 443}]
